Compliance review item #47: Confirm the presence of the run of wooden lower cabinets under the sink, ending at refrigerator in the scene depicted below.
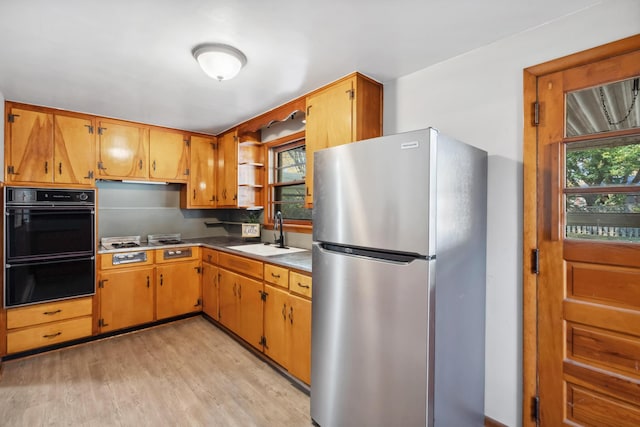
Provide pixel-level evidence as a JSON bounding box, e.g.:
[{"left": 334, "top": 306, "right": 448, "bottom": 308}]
[{"left": 208, "top": 252, "right": 311, "bottom": 384}]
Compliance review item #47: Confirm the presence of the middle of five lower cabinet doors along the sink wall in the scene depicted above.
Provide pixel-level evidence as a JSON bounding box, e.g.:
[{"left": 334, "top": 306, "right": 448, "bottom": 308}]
[{"left": 238, "top": 276, "right": 264, "bottom": 350}]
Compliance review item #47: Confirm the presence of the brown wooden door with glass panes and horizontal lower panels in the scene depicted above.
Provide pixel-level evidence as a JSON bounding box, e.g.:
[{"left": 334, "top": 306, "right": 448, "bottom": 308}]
[{"left": 537, "top": 51, "right": 640, "bottom": 426}]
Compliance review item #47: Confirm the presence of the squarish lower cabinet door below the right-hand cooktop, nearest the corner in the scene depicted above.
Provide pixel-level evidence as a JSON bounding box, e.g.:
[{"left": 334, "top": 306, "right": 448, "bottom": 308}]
[{"left": 156, "top": 261, "right": 202, "bottom": 320}]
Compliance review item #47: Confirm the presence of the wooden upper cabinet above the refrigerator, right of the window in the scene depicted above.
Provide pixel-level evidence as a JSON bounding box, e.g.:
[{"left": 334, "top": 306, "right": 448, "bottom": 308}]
[{"left": 305, "top": 73, "right": 382, "bottom": 207}]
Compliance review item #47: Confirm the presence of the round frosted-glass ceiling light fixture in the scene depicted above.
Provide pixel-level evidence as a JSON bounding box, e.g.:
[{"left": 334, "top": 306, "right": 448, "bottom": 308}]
[{"left": 193, "top": 43, "right": 247, "bottom": 81}]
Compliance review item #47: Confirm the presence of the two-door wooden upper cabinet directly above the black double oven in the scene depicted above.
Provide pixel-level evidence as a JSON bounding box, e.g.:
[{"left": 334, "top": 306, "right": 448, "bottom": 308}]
[{"left": 5, "top": 102, "right": 95, "bottom": 185}]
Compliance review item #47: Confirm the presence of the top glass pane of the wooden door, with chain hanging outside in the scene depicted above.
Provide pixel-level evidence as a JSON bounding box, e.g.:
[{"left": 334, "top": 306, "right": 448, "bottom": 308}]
[{"left": 565, "top": 77, "right": 640, "bottom": 137}]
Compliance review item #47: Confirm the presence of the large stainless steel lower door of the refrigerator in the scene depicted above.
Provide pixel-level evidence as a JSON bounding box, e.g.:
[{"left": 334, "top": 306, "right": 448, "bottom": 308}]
[{"left": 311, "top": 243, "right": 435, "bottom": 427}]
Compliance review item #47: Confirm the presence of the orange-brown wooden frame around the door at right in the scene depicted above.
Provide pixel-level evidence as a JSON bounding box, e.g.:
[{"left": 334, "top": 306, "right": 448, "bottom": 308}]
[{"left": 522, "top": 34, "right": 640, "bottom": 427}]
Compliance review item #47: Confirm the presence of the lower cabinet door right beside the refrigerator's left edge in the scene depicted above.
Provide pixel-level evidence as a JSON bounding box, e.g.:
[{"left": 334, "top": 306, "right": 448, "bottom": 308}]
[{"left": 287, "top": 295, "right": 311, "bottom": 384}]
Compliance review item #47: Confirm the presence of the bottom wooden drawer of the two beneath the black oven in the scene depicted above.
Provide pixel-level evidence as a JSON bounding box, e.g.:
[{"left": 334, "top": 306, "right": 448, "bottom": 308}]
[{"left": 7, "top": 316, "right": 92, "bottom": 353}]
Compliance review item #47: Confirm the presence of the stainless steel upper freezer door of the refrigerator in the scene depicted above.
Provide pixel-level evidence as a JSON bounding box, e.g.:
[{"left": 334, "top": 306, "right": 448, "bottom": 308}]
[{"left": 313, "top": 129, "right": 438, "bottom": 255}]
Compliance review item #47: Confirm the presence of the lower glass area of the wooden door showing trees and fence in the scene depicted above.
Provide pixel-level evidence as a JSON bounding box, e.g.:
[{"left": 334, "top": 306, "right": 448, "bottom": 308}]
[{"left": 564, "top": 135, "right": 640, "bottom": 242}]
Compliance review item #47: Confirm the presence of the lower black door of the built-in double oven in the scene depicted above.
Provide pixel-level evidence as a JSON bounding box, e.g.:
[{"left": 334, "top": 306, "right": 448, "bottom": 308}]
[{"left": 5, "top": 257, "right": 96, "bottom": 307}]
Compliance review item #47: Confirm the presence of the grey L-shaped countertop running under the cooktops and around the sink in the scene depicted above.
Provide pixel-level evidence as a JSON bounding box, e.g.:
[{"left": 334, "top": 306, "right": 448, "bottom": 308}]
[{"left": 98, "top": 236, "right": 311, "bottom": 273}]
